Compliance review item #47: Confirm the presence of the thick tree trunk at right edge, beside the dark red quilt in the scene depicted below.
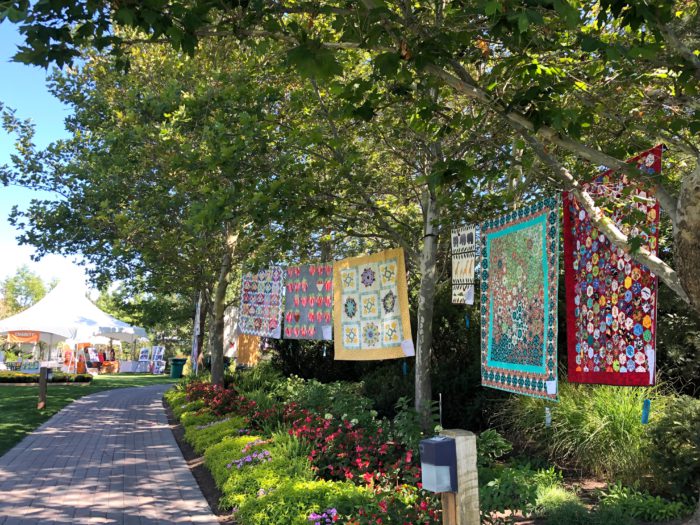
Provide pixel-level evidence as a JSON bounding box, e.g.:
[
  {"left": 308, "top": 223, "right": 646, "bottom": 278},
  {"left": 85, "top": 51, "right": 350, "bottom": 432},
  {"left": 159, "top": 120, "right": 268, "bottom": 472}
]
[{"left": 674, "top": 158, "right": 700, "bottom": 314}]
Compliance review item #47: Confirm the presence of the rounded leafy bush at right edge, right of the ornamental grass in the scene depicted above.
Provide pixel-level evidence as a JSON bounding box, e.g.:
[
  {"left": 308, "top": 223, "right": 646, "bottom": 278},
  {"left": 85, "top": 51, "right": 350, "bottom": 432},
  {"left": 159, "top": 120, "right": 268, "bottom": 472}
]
[{"left": 651, "top": 396, "right": 700, "bottom": 495}]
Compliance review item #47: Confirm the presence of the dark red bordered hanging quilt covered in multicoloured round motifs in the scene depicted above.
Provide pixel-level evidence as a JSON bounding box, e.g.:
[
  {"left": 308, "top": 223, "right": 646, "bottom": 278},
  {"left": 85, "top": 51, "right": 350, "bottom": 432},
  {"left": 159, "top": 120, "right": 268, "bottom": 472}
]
[{"left": 564, "top": 146, "right": 663, "bottom": 386}]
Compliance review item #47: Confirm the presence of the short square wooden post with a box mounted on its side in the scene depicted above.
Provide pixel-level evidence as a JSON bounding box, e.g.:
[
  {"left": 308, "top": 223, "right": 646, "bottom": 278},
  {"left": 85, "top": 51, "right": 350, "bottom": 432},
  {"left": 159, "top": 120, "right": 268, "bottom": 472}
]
[{"left": 440, "top": 429, "right": 481, "bottom": 525}]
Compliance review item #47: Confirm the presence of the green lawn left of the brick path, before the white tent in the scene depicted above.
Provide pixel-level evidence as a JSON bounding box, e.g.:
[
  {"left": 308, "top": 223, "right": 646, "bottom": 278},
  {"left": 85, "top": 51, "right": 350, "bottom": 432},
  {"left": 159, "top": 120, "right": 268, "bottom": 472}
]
[{"left": 0, "top": 374, "right": 177, "bottom": 456}]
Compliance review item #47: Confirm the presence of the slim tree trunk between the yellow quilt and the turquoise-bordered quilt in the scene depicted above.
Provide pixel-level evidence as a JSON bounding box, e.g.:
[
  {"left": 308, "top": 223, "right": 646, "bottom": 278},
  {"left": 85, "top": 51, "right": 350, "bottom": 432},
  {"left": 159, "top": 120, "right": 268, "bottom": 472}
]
[{"left": 415, "top": 184, "right": 440, "bottom": 431}]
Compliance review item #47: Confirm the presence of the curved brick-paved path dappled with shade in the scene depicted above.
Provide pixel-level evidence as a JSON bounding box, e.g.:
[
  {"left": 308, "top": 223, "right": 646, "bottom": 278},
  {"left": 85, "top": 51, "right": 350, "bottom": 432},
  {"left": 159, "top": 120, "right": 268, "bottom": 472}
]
[{"left": 0, "top": 385, "right": 217, "bottom": 525}]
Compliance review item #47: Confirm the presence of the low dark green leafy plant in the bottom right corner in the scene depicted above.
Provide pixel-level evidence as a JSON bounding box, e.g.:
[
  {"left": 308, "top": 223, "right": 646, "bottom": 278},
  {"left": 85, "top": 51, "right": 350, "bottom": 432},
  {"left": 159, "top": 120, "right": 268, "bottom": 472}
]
[{"left": 600, "top": 483, "right": 693, "bottom": 522}]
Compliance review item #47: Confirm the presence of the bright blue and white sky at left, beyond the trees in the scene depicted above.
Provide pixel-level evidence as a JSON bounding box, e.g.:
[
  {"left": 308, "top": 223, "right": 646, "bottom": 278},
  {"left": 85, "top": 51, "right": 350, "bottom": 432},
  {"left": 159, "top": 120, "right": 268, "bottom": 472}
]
[{"left": 0, "top": 21, "right": 84, "bottom": 281}]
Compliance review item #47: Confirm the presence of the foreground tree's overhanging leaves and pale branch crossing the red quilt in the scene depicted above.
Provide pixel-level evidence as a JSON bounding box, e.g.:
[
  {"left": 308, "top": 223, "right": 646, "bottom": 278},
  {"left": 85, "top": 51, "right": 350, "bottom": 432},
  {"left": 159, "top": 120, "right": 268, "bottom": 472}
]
[{"left": 4, "top": 0, "right": 700, "bottom": 311}]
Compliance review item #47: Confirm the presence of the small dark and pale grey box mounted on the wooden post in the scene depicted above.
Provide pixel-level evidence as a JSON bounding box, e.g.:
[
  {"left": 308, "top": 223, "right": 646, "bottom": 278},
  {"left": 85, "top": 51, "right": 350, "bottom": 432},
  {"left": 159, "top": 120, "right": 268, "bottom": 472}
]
[{"left": 419, "top": 436, "right": 457, "bottom": 492}]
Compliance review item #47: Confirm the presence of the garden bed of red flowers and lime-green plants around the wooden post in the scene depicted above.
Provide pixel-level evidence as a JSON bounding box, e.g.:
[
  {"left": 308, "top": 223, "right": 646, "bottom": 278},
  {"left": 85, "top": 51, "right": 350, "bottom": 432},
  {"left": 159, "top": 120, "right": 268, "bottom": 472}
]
[{"left": 165, "top": 367, "right": 692, "bottom": 525}]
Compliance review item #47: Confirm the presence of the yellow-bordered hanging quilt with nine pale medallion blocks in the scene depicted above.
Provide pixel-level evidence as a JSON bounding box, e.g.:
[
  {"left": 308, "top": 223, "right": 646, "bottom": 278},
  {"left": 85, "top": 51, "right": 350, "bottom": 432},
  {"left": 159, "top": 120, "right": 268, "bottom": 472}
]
[{"left": 333, "top": 248, "right": 413, "bottom": 361}]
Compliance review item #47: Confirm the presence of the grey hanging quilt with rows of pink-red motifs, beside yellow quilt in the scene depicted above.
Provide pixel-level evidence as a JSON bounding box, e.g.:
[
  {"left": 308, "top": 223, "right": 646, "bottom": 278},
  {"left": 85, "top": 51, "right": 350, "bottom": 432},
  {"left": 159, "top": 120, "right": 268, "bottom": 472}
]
[{"left": 284, "top": 263, "right": 333, "bottom": 340}]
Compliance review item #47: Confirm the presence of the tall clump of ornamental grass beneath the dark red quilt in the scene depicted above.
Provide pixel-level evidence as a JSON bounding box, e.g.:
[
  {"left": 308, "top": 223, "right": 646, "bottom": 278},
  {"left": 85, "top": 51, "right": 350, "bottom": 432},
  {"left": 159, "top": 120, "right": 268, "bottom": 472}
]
[{"left": 493, "top": 376, "right": 672, "bottom": 481}]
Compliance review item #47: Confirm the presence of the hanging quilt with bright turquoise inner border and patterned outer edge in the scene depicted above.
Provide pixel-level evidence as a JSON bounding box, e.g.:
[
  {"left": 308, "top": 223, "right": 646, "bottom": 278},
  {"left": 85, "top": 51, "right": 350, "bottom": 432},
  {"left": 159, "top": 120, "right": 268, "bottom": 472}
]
[{"left": 481, "top": 198, "right": 559, "bottom": 400}]
